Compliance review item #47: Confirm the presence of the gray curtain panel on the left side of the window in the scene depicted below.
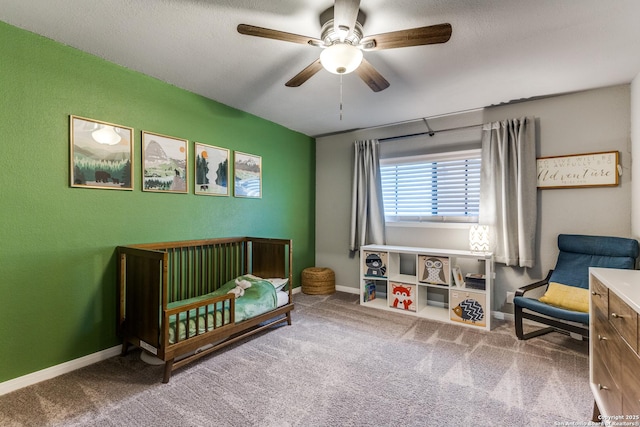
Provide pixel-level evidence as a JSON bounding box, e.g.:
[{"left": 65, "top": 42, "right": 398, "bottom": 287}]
[{"left": 349, "top": 139, "right": 386, "bottom": 251}]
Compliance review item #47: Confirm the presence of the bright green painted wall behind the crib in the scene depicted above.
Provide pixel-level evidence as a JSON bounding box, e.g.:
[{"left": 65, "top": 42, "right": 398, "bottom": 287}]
[{"left": 0, "top": 22, "right": 315, "bottom": 382}]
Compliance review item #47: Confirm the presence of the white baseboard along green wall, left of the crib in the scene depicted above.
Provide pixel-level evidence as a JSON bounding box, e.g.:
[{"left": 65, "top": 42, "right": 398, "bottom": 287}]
[{"left": 0, "top": 345, "right": 122, "bottom": 396}]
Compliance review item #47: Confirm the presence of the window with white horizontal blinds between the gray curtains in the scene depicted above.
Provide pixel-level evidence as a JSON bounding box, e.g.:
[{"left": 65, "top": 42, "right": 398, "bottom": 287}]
[{"left": 380, "top": 149, "right": 480, "bottom": 222}]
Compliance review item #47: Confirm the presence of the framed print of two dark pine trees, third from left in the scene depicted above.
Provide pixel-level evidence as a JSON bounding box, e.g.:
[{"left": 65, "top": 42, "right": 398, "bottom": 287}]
[{"left": 193, "top": 142, "right": 230, "bottom": 196}]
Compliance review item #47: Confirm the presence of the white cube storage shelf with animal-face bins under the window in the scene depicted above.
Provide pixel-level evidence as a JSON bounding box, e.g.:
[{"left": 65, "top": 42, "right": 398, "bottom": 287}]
[{"left": 360, "top": 245, "right": 494, "bottom": 330}]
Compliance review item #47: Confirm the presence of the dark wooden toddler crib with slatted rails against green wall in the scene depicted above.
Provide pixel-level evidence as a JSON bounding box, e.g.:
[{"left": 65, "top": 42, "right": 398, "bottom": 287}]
[{"left": 118, "top": 237, "right": 293, "bottom": 383}]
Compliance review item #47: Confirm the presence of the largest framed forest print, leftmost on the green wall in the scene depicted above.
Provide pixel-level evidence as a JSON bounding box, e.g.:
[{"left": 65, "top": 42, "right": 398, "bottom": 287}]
[{"left": 69, "top": 115, "right": 133, "bottom": 190}]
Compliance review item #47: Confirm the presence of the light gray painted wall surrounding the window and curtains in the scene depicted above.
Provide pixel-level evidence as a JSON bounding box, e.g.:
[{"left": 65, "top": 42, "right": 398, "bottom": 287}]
[{"left": 316, "top": 85, "right": 637, "bottom": 313}]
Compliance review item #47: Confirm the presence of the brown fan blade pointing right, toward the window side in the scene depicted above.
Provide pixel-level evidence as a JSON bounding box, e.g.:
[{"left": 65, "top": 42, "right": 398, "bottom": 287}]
[{"left": 361, "top": 24, "right": 451, "bottom": 50}]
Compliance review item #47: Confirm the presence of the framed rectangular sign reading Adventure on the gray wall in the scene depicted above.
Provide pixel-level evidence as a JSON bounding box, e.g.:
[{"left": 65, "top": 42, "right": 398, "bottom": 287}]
[{"left": 537, "top": 151, "right": 618, "bottom": 188}]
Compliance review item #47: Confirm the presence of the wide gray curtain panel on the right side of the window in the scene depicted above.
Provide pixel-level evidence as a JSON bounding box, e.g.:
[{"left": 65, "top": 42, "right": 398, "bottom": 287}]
[{"left": 478, "top": 117, "right": 537, "bottom": 267}]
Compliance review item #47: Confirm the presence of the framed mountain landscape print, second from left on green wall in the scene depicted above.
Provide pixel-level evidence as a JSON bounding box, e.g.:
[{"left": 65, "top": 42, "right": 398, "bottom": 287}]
[{"left": 142, "top": 131, "right": 189, "bottom": 193}]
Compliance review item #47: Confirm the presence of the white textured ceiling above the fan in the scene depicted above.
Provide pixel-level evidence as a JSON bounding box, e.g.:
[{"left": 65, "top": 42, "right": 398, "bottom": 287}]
[{"left": 0, "top": 0, "right": 640, "bottom": 136}]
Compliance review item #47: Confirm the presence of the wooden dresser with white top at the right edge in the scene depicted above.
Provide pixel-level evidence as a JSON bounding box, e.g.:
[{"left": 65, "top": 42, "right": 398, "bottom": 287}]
[{"left": 589, "top": 268, "right": 640, "bottom": 425}]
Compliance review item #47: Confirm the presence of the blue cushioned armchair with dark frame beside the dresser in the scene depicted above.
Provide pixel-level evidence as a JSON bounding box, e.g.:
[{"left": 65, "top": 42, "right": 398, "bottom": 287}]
[{"left": 513, "top": 234, "right": 638, "bottom": 340}]
